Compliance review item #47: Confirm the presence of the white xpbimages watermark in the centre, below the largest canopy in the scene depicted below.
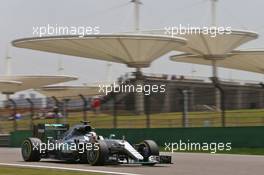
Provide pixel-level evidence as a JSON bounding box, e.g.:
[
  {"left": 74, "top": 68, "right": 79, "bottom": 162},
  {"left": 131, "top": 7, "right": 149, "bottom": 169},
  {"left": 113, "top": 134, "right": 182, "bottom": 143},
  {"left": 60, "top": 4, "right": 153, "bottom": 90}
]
[{"left": 99, "top": 82, "right": 166, "bottom": 95}]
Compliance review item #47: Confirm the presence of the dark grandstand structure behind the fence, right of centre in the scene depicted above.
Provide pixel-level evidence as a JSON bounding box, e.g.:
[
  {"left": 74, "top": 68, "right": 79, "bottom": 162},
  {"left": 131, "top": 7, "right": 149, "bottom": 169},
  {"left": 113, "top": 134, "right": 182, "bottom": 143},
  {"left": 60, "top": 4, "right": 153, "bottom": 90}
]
[{"left": 102, "top": 74, "right": 264, "bottom": 113}]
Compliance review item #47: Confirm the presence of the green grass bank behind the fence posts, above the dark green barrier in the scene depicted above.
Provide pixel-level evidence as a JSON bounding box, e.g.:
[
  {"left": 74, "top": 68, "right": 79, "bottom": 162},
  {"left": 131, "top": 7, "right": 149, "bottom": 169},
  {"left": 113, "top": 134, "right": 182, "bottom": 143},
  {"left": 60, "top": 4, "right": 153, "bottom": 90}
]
[{"left": 0, "top": 109, "right": 264, "bottom": 133}]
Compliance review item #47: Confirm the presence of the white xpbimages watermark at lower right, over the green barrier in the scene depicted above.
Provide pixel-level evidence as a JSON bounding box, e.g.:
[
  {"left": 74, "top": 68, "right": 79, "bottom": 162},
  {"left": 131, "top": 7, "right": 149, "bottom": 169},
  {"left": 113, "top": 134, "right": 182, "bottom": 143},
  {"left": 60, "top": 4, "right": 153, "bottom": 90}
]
[{"left": 164, "top": 140, "right": 232, "bottom": 154}]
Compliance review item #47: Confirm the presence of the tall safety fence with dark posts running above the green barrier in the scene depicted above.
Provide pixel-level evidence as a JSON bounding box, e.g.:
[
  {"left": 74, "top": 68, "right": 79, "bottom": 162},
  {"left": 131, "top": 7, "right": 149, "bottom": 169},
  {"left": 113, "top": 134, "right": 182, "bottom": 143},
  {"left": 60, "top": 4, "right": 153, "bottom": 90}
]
[{"left": 0, "top": 75, "right": 264, "bottom": 133}]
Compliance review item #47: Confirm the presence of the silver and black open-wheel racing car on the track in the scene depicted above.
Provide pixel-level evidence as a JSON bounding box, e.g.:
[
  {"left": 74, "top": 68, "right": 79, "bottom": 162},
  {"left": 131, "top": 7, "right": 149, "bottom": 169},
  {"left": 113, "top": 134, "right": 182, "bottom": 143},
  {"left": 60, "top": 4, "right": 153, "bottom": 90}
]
[{"left": 21, "top": 122, "right": 171, "bottom": 166}]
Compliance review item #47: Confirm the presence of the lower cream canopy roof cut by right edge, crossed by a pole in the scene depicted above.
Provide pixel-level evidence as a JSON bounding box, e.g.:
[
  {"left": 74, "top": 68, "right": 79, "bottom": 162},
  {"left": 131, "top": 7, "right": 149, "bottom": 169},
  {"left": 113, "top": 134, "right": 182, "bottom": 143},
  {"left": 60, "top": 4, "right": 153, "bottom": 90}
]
[{"left": 171, "top": 50, "right": 264, "bottom": 73}]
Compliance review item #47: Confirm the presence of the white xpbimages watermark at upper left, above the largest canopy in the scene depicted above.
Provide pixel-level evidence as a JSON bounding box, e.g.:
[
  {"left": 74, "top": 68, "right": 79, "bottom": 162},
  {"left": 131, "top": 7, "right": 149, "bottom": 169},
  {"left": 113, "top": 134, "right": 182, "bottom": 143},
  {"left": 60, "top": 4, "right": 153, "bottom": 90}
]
[{"left": 32, "top": 24, "right": 100, "bottom": 37}]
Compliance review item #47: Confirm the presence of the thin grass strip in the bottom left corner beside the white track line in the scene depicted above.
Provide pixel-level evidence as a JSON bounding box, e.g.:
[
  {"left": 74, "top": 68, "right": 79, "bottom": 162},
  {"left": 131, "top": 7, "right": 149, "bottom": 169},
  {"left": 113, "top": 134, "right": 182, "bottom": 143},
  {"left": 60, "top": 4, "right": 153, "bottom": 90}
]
[{"left": 0, "top": 166, "right": 102, "bottom": 175}]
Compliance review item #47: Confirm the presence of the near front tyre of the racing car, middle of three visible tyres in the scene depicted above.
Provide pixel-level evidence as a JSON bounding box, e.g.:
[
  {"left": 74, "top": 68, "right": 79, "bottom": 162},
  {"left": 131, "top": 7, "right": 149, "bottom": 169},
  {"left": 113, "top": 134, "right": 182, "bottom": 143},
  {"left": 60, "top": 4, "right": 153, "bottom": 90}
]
[{"left": 87, "top": 140, "right": 109, "bottom": 166}]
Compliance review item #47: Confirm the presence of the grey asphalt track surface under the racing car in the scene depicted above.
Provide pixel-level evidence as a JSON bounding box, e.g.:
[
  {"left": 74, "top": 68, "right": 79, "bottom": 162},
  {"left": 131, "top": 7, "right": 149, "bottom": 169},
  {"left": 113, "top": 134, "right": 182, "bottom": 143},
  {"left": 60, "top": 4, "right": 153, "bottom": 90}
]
[{"left": 0, "top": 148, "right": 264, "bottom": 175}]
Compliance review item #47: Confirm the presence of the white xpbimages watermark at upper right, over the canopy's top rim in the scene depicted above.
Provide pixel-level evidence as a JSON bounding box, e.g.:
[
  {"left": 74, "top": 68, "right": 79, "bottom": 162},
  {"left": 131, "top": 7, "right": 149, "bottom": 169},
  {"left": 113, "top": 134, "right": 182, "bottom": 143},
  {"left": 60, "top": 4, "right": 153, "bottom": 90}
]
[{"left": 164, "top": 24, "right": 232, "bottom": 38}]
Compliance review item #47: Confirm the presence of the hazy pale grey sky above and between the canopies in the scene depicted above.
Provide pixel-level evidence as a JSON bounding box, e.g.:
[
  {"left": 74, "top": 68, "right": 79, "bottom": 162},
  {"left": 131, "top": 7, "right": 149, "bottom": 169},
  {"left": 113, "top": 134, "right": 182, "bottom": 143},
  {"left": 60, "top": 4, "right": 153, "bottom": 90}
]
[{"left": 0, "top": 0, "right": 264, "bottom": 91}]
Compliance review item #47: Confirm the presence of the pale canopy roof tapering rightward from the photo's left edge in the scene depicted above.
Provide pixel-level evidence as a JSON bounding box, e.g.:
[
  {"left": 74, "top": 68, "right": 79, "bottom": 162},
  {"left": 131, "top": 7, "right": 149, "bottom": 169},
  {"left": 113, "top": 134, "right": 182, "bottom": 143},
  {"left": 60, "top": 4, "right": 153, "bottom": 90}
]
[{"left": 0, "top": 75, "right": 77, "bottom": 93}]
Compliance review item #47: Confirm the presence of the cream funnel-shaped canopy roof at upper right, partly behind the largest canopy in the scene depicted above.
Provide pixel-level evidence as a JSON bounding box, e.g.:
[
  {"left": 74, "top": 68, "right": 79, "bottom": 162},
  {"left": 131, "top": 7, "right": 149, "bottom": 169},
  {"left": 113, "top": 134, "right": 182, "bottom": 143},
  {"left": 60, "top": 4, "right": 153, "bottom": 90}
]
[{"left": 143, "top": 30, "right": 258, "bottom": 57}]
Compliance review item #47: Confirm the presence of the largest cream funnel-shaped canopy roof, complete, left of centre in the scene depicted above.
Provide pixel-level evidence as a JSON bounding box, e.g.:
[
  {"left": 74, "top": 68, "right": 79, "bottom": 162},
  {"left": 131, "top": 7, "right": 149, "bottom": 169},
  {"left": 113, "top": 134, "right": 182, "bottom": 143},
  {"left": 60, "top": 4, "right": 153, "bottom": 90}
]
[{"left": 12, "top": 34, "right": 186, "bottom": 68}]
